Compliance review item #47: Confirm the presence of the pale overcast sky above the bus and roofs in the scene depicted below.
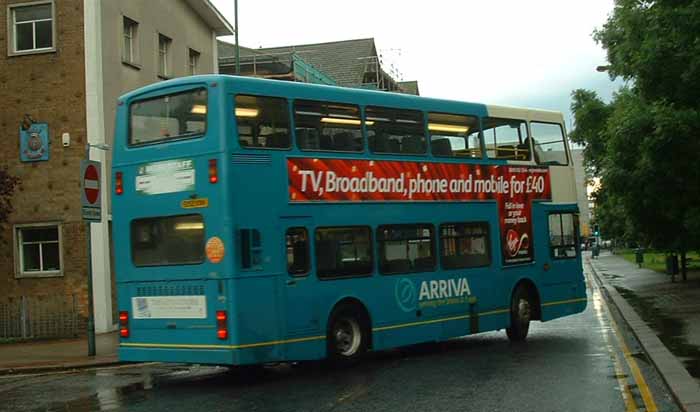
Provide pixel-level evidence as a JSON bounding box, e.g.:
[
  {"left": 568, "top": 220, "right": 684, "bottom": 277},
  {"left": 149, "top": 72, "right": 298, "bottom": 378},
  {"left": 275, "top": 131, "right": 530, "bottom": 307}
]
[{"left": 212, "top": 0, "right": 621, "bottom": 127}]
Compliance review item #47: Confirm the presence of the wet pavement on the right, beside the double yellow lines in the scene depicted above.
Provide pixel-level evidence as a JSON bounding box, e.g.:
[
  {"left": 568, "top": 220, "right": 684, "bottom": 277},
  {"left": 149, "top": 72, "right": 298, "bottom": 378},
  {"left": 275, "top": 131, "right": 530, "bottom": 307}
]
[{"left": 585, "top": 253, "right": 700, "bottom": 412}]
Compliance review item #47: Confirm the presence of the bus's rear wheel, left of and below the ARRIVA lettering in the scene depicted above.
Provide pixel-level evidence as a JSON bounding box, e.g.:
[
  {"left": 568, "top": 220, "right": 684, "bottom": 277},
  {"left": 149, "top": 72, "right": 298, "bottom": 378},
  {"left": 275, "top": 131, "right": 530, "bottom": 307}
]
[{"left": 327, "top": 306, "right": 368, "bottom": 362}]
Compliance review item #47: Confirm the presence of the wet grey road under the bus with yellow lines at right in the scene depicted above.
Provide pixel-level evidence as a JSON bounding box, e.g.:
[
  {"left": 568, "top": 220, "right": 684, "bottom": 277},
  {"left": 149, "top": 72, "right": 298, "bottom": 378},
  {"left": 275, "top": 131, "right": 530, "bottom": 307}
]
[{"left": 0, "top": 268, "right": 678, "bottom": 412}]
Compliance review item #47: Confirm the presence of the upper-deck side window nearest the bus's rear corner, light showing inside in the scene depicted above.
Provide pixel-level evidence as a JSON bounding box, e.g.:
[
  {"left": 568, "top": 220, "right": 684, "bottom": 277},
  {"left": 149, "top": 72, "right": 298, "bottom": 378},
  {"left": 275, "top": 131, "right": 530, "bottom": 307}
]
[{"left": 235, "top": 94, "right": 291, "bottom": 149}]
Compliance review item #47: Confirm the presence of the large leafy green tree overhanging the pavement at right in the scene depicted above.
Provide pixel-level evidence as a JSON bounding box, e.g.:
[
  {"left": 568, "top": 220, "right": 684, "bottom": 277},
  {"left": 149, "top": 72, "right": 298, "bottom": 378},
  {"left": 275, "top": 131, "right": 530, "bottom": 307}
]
[{"left": 571, "top": 0, "right": 700, "bottom": 279}]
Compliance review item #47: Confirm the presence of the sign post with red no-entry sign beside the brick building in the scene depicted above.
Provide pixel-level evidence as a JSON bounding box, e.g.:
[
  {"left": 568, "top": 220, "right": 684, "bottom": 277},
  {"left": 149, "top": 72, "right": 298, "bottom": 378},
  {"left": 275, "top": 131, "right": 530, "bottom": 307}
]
[{"left": 80, "top": 159, "right": 102, "bottom": 356}]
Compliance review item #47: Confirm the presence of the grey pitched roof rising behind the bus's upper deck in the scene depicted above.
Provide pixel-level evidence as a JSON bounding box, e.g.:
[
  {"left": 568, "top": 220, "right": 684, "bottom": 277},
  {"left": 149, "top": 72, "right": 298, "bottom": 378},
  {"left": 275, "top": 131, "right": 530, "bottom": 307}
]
[{"left": 219, "top": 38, "right": 377, "bottom": 86}]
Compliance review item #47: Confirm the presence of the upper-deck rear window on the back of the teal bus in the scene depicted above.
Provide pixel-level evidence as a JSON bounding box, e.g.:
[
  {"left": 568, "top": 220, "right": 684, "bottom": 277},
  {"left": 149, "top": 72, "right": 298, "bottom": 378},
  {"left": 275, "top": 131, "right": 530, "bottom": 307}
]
[{"left": 129, "top": 88, "right": 207, "bottom": 146}]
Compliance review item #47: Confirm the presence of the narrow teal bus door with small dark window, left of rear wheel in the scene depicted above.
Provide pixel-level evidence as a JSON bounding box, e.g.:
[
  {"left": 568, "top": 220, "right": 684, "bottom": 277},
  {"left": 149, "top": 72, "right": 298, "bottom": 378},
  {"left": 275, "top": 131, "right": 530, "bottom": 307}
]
[{"left": 281, "top": 217, "right": 319, "bottom": 336}]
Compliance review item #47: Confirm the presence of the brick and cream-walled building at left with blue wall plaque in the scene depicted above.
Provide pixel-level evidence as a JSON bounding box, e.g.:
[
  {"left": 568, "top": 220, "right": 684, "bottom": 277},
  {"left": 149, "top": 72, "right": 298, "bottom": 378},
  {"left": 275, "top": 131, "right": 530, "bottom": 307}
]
[{"left": 0, "top": 0, "right": 233, "bottom": 338}]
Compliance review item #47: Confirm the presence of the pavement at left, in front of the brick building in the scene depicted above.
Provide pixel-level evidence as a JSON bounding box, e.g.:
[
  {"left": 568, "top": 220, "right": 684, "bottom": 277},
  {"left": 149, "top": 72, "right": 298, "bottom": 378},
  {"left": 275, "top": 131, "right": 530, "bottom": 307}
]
[{"left": 0, "top": 332, "right": 119, "bottom": 375}]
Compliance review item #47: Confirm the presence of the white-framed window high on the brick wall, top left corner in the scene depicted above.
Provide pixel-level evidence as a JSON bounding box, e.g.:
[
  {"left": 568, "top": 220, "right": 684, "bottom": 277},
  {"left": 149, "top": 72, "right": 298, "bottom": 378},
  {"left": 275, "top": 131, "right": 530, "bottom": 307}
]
[{"left": 8, "top": 2, "right": 54, "bottom": 53}]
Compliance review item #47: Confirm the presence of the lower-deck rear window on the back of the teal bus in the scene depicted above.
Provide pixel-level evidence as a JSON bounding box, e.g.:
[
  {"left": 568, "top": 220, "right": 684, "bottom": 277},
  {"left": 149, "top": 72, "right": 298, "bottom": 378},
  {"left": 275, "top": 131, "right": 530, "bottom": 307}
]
[{"left": 131, "top": 215, "right": 204, "bottom": 266}]
